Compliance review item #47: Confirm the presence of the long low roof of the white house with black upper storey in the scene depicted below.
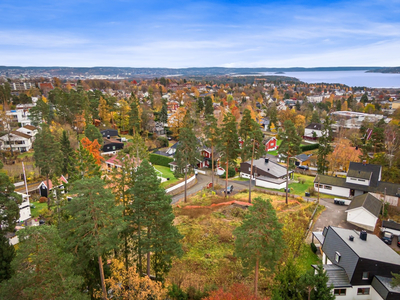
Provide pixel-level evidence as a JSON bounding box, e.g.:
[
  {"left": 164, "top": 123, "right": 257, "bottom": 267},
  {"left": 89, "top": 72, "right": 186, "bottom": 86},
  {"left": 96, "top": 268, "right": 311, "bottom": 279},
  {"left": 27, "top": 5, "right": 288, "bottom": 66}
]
[{"left": 314, "top": 175, "right": 400, "bottom": 196}]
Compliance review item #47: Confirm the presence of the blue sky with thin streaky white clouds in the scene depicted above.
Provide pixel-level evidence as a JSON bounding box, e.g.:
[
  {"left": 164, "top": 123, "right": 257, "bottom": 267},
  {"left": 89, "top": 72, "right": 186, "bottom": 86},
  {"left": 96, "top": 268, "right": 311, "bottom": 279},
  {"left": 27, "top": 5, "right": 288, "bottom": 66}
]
[{"left": 0, "top": 0, "right": 400, "bottom": 68}]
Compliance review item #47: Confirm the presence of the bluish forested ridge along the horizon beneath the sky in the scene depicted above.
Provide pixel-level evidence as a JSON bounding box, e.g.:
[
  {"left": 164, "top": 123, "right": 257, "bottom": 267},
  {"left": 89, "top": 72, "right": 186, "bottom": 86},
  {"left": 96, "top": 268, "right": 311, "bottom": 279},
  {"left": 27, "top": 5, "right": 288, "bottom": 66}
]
[{"left": 0, "top": 66, "right": 381, "bottom": 78}]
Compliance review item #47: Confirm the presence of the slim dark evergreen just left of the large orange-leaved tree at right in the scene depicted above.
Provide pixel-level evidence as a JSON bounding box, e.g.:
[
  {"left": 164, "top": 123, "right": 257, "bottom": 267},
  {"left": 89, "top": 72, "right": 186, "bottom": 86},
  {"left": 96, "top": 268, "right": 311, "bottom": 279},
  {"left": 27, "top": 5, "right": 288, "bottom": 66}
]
[{"left": 317, "top": 116, "right": 333, "bottom": 175}]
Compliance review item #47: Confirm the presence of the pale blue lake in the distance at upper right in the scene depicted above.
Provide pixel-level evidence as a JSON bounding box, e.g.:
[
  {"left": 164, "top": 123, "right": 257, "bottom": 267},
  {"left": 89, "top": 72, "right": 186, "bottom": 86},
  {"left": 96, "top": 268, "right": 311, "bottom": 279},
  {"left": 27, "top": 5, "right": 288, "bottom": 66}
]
[{"left": 263, "top": 71, "right": 400, "bottom": 88}]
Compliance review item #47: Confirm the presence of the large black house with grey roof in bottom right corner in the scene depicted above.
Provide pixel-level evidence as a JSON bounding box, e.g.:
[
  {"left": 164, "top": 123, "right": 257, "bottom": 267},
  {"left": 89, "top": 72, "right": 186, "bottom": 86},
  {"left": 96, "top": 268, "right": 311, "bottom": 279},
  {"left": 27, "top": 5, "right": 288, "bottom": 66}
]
[{"left": 313, "top": 226, "right": 400, "bottom": 300}]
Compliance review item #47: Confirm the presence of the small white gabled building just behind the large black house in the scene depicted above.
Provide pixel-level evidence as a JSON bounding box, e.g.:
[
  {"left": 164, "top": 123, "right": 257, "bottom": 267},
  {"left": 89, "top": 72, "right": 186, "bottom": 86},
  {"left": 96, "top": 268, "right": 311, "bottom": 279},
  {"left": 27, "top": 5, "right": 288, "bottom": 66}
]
[{"left": 346, "top": 193, "right": 382, "bottom": 231}]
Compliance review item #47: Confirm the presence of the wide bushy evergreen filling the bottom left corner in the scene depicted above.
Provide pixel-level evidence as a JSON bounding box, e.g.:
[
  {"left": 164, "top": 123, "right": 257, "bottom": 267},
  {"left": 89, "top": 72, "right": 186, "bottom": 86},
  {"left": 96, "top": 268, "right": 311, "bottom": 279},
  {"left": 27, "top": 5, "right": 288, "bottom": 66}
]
[{"left": 0, "top": 226, "right": 88, "bottom": 300}]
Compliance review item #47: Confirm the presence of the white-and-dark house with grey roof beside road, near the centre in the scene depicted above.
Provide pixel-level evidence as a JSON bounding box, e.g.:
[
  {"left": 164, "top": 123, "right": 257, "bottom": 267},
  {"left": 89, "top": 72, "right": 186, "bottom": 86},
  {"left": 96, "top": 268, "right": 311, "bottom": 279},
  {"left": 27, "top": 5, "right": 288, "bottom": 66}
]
[{"left": 240, "top": 157, "right": 293, "bottom": 189}]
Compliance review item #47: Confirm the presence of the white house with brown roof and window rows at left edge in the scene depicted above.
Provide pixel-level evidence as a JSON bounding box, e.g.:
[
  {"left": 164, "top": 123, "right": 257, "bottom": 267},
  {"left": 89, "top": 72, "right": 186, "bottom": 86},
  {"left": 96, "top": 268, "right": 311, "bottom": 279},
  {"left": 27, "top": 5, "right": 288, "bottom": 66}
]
[{"left": 0, "top": 125, "right": 37, "bottom": 152}]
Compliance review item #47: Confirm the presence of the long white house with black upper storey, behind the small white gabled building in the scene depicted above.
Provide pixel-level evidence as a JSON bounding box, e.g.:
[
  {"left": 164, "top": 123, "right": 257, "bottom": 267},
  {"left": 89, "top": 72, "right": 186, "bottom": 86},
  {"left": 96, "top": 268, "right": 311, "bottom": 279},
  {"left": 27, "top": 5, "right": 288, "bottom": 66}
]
[{"left": 314, "top": 162, "right": 400, "bottom": 206}]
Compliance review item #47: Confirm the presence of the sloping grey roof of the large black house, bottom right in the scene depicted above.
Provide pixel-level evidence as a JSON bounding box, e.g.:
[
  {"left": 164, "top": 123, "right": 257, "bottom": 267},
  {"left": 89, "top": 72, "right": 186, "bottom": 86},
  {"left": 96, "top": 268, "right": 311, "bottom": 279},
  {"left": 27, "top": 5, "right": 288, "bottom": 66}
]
[{"left": 330, "top": 227, "right": 400, "bottom": 265}]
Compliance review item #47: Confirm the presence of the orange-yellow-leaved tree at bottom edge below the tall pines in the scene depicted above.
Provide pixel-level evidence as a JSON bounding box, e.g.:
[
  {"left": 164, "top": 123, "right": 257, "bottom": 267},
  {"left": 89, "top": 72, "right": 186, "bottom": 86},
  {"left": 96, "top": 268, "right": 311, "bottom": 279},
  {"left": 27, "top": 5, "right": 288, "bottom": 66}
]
[{"left": 96, "top": 259, "right": 167, "bottom": 300}]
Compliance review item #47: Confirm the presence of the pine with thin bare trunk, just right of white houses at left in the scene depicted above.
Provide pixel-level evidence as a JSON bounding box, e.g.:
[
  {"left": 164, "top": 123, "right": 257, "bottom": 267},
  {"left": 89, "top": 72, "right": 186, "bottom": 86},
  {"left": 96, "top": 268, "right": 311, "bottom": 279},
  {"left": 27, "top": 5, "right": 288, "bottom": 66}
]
[{"left": 33, "top": 123, "right": 61, "bottom": 210}]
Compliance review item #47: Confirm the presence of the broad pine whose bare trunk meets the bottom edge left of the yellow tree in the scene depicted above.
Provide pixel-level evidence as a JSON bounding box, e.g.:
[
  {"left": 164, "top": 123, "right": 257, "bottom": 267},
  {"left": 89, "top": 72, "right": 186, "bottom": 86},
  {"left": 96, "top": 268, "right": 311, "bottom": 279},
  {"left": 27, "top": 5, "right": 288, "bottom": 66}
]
[{"left": 64, "top": 177, "right": 125, "bottom": 299}]
